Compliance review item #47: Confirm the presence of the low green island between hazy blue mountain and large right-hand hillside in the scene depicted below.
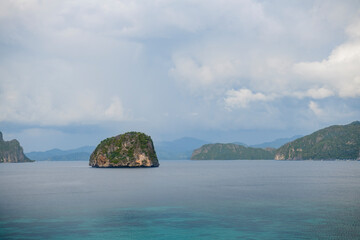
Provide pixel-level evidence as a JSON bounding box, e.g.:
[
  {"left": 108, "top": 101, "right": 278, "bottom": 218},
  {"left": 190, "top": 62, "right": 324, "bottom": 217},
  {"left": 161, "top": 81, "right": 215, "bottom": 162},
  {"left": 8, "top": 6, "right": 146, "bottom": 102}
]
[{"left": 191, "top": 143, "right": 275, "bottom": 160}]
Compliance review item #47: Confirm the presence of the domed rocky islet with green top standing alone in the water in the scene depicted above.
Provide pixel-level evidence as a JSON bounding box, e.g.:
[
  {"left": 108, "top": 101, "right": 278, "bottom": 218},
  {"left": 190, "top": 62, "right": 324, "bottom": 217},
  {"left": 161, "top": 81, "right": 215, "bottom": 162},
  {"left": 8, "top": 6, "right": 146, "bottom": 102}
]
[{"left": 89, "top": 132, "right": 159, "bottom": 168}]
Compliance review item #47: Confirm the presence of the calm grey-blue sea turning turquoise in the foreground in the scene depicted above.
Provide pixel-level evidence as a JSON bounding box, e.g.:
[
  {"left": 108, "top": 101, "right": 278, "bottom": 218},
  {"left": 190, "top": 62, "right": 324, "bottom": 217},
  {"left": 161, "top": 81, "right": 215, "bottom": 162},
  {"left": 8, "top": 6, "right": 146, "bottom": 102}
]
[{"left": 0, "top": 160, "right": 360, "bottom": 240}]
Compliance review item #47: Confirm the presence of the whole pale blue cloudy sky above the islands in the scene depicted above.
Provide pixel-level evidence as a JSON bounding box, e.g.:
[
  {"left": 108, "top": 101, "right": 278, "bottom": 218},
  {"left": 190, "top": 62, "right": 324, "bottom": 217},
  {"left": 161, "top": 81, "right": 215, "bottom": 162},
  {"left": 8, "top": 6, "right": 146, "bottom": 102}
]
[{"left": 0, "top": 0, "right": 360, "bottom": 152}]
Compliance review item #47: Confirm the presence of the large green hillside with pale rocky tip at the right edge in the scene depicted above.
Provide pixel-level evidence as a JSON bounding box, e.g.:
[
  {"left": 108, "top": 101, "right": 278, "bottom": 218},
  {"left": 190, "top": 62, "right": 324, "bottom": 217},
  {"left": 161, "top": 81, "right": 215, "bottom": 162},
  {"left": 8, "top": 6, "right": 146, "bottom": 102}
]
[{"left": 275, "top": 121, "right": 360, "bottom": 160}]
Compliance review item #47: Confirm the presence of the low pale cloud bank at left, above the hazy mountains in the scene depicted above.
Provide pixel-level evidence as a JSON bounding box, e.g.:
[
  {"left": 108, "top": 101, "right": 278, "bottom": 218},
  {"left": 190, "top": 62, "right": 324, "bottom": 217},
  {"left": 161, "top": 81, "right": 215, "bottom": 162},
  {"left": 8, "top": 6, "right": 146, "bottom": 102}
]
[{"left": 0, "top": 87, "right": 129, "bottom": 125}]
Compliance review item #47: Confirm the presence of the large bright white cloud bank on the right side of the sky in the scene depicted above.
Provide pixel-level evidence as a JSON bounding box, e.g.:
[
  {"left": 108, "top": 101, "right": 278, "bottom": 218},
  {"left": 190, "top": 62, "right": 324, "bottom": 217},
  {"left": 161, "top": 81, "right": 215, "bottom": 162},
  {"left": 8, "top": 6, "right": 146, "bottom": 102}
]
[{"left": 170, "top": 13, "right": 360, "bottom": 113}]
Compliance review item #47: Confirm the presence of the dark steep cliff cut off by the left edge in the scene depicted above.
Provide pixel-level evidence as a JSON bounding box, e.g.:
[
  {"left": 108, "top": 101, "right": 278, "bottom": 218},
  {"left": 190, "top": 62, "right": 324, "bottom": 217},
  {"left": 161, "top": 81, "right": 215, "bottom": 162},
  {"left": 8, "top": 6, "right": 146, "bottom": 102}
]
[{"left": 0, "top": 132, "right": 32, "bottom": 163}]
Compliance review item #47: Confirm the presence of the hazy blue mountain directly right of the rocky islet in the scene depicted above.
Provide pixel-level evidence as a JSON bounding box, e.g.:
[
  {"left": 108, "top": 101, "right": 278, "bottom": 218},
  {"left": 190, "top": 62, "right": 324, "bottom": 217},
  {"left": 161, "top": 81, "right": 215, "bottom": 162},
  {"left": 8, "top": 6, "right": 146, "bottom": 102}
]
[{"left": 155, "top": 137, "right": 209, "bottom": 160}]
